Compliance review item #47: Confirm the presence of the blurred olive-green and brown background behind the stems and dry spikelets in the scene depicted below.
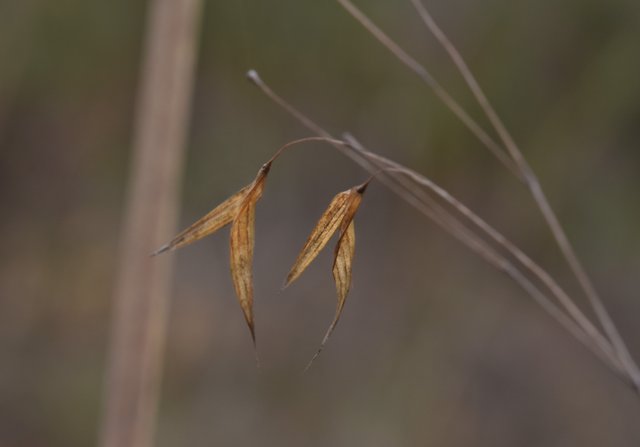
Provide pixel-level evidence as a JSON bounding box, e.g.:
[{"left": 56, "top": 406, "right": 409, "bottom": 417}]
[{"left": 0, "top": 0, "right": 640, "bottom": 447}]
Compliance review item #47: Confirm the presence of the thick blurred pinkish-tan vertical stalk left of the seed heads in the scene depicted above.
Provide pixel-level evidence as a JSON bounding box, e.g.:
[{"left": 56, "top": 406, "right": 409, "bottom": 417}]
[{"left": 100, "top": 0, "right": 202, "bottom": 447}]
